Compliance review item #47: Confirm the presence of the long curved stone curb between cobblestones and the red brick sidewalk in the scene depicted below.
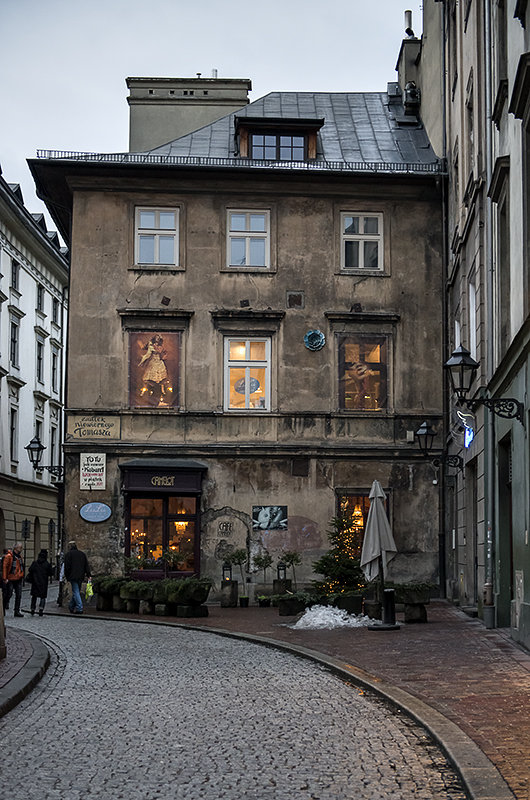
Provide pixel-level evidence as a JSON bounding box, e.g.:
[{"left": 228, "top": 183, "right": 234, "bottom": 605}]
[{"left": 54, "top": 612, "right": 515, "bottom": 800}]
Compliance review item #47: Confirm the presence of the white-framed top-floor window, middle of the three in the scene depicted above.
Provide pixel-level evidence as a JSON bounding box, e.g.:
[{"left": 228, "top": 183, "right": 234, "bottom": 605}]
[{"left": 226, "top": 209, "right": 270, "bottom": 269}]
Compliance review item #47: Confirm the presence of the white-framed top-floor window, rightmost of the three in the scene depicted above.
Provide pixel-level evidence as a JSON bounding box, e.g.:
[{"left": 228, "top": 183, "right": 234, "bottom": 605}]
[{"left": 340, "top": 211, "right": 383, "bottom": 272}]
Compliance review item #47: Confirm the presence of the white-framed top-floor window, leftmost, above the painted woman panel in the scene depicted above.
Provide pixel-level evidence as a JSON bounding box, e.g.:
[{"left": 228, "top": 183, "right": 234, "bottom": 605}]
[{"left": 135, "top": 207, "right": 179, "bottom": 267}]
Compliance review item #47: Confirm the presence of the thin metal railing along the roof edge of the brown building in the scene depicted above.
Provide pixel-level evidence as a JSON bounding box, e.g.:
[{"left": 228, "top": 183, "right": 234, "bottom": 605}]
[{"left": 37, "top": 150, "right": 444, "bottom": 175}]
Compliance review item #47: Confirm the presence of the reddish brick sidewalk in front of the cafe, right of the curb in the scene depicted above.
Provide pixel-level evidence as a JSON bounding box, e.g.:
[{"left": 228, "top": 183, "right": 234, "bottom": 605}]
[{"left": 4, "top": 601, "right": 530, "bottom": 800}]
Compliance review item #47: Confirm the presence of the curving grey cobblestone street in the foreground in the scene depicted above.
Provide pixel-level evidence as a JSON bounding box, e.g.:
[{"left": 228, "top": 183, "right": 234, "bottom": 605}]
[{"left": 0, "top": 615, "right": 465, "bottom": 800}]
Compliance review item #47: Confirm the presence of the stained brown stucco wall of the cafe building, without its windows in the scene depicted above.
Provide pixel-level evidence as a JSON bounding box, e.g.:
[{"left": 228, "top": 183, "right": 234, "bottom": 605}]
[{"left": 65, "top": 167, "right": 443, "bottom": 583}]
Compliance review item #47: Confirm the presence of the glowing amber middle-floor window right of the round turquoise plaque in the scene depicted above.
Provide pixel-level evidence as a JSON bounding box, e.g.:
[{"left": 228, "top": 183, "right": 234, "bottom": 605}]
[{"left": 339, "top": 334, "right": 388, "bottom": 411}]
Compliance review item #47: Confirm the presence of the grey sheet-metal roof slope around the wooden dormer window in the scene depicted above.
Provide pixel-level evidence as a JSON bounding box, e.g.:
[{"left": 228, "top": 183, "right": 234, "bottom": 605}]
[{"left": 149, "top": 92, "right": 438, "bottom": 165}]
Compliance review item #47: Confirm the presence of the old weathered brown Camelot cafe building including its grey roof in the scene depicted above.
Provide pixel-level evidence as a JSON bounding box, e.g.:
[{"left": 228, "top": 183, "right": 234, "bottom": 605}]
[{"left": 30, "top": 76, "right": 444, "bottom": 592}]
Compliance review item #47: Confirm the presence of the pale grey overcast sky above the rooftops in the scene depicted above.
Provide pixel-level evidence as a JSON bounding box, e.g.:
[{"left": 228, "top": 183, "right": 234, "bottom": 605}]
[{"left": 0, "top": 0, "right": 421, "bottom": 227}]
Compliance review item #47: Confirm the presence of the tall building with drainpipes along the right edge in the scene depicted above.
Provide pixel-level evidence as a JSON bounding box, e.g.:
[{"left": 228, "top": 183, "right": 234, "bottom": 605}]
[{"left": 408, "top": 0, "right": 530, "bottom": 646}]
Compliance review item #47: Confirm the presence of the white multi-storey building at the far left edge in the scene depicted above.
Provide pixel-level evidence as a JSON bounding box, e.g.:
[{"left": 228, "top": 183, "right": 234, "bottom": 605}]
[{"left": 0, "top": 167, "right": 69, "bottom": 561}]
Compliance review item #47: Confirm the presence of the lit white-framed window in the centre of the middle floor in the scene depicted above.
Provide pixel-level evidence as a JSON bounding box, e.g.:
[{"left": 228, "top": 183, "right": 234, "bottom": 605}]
[{"left": 224, "top": 336, "right": 271, "bottom": 411}]
